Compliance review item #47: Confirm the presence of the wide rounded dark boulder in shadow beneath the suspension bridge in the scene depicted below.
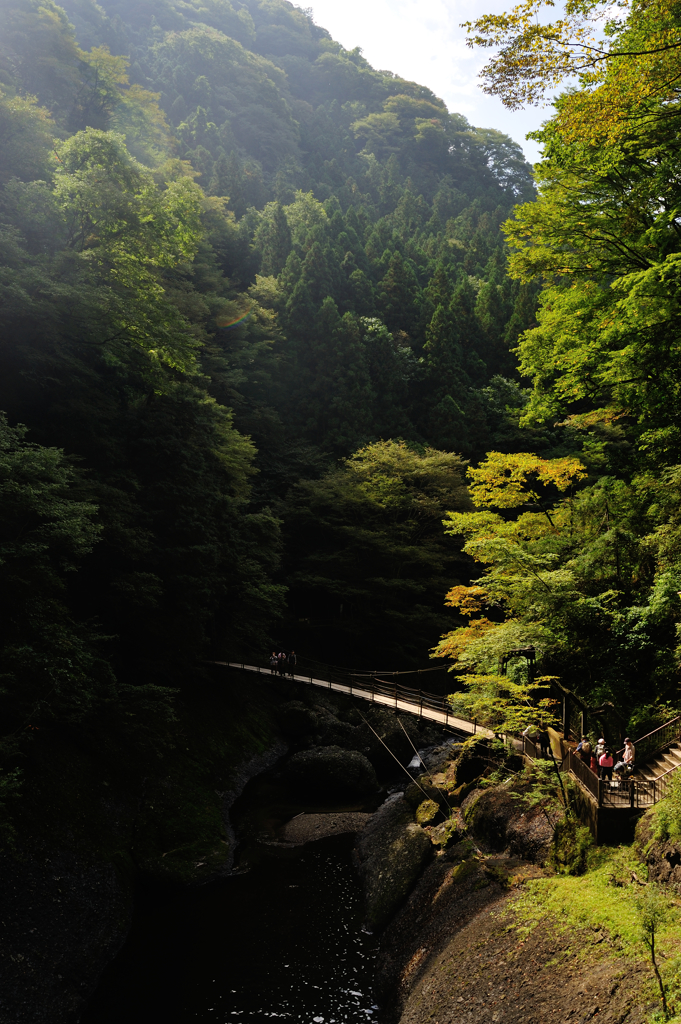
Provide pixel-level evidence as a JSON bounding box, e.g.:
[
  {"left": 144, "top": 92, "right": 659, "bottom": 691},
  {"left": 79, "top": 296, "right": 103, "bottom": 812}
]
[{"left": 283, "top": 746, "right": 379, "bottom": 799}]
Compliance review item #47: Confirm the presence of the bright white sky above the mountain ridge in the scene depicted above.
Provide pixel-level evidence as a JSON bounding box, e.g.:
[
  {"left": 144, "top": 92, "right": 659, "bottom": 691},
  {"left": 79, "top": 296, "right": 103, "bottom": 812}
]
[{"left": 299, "top": 0, "right": 551, "bottom": 163}]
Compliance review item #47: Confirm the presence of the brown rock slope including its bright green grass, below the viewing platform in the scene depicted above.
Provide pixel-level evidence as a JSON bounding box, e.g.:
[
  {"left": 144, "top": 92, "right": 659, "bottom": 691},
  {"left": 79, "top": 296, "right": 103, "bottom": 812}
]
[{"left": 376, "top": 767, "right": 681, "bottom": 1024}]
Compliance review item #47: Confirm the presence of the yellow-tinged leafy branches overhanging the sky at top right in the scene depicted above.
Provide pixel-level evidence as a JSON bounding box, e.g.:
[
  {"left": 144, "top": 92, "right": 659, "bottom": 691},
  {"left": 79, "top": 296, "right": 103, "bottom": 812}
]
[{"left": 465, "top": 0, "right": 681, "bottom": 144}]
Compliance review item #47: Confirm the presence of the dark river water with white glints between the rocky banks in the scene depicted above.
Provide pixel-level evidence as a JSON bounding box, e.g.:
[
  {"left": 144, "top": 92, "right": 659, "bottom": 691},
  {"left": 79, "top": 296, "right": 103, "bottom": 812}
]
[{"left": 82, "top": 778, "right": 378, "bottom": 1024}]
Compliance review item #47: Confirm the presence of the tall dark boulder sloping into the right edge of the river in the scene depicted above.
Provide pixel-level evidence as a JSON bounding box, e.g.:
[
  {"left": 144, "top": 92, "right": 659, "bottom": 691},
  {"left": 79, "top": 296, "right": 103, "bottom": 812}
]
[{"left": 356, "top": 797, "right": 432, "bottom": 931}]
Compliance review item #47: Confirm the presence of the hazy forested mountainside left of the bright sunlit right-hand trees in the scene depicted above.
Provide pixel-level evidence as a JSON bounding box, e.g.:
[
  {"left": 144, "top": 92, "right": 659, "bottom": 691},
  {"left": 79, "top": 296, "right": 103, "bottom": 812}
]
[{"left": 0, "top": 0, "right": 536, "bottom": 741}]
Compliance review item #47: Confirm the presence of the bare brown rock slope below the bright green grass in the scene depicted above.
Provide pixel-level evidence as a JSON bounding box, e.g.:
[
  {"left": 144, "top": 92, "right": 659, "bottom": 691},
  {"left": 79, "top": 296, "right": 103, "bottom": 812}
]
[{"left": 393, "top": 897, "right": 655, "bottom": 1024}]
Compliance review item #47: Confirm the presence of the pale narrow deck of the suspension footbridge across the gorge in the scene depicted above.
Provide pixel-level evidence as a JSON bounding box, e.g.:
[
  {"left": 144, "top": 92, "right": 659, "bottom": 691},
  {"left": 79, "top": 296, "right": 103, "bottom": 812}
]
[{"left": 218, "top": 662, "right": 495, "bottom": 739}]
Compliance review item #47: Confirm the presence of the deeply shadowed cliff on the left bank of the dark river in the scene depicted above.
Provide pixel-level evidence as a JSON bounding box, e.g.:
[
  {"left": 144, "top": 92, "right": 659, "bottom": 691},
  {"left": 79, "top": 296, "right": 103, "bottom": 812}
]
[{"left": 0, "top": 678, "right": 280, "bottom": 1024}]
